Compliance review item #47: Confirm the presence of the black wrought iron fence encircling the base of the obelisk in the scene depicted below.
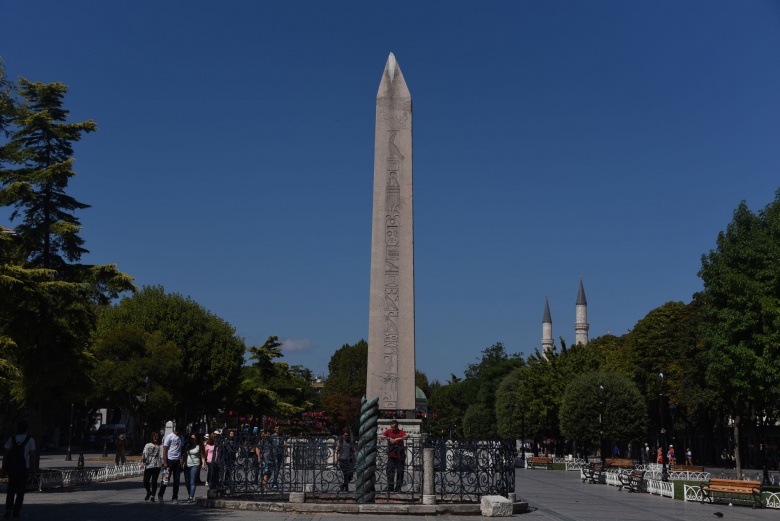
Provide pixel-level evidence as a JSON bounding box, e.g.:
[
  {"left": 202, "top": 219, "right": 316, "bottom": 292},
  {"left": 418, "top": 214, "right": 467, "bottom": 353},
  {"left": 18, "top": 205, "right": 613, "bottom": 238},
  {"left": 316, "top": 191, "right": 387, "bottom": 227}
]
[{"left": 215, "top": 436, "right": 515, "bottom": 502}]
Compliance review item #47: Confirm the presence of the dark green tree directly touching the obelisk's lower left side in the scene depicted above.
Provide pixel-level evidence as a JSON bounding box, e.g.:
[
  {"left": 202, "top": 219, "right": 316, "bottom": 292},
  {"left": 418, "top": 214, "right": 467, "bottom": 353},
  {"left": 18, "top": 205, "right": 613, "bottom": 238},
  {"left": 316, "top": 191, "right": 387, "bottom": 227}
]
[{"left": 322, "top": 339, "right": 368, "bottom": 429}]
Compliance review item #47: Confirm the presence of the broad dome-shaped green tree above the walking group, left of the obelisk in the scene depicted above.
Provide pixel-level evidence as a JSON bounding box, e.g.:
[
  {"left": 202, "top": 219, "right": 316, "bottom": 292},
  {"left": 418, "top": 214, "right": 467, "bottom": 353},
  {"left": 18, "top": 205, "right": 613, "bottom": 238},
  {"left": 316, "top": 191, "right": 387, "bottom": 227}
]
[{"left": 97, "top": 286, "right": 246, "bottom": 418}]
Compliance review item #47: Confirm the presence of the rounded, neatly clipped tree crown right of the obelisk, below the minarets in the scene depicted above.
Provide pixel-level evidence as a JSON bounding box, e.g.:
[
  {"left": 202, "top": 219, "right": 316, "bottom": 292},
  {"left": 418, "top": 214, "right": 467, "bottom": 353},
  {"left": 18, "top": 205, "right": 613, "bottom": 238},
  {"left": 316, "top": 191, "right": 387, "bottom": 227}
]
[{"left": 560, "top": 372, "right": 647, "bottom": 443}]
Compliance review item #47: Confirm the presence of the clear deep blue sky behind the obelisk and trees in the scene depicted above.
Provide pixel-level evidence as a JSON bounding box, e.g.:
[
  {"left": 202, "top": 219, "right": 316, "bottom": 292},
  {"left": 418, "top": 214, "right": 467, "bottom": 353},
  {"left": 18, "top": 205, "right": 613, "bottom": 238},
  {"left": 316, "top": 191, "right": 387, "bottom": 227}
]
[{"left": 0, "top": 0, "right": 780, "bottom": 381}]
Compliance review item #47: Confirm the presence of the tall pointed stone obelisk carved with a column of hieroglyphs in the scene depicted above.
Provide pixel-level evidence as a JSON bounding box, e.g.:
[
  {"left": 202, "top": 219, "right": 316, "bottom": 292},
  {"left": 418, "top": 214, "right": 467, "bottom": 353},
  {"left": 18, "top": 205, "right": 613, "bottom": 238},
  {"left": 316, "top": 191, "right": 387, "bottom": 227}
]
[{"left": 366, "top": 53, "right": 415, "bottom": 411}]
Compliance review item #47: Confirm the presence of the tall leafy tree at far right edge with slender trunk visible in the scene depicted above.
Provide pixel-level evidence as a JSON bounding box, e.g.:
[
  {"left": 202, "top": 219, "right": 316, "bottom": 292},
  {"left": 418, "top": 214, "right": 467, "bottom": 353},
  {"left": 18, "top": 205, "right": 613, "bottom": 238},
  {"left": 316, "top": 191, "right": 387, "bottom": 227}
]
[{"left": 699, "top": 190, "right": 780, "bottom": 477}]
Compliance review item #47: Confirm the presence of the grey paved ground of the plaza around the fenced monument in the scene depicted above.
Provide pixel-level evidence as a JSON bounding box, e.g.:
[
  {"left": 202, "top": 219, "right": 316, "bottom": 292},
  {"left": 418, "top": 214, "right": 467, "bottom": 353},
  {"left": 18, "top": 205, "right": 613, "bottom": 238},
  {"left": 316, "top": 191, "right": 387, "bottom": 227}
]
[{"left": 7, "top": 453, "right": 780, "bottom": 521}]
